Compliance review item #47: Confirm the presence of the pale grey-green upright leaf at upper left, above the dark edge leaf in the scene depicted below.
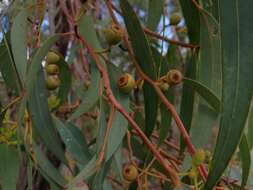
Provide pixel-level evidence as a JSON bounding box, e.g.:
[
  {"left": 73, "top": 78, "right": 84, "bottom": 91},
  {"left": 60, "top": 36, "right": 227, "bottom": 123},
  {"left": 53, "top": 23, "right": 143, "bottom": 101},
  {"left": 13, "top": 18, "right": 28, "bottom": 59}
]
[{"left": 11, "top": 9, "right": 27, "bottom": 83}]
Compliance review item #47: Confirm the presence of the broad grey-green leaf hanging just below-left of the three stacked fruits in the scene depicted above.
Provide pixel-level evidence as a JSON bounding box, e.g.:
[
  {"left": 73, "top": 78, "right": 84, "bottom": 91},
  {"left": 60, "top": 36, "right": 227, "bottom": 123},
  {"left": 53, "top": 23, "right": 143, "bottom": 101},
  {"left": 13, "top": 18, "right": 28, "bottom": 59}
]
[{"left": 28, "top": 65, "right": 67, "bottom": 163}]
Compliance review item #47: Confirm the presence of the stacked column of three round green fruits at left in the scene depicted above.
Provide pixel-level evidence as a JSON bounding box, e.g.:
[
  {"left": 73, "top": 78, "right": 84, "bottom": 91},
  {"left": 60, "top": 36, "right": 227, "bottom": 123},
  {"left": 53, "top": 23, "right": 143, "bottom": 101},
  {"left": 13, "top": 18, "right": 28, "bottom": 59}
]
[{"left": 45, "top": 51, "right": 61, "bottom": 90}]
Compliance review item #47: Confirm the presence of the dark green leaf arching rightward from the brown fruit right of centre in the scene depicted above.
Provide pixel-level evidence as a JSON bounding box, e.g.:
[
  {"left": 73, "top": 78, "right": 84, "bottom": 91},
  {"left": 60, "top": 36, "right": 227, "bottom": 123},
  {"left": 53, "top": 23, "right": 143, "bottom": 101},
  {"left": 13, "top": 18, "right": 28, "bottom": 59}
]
[{"left": 184, "top": 78, "right": 220, "bottom": 112}]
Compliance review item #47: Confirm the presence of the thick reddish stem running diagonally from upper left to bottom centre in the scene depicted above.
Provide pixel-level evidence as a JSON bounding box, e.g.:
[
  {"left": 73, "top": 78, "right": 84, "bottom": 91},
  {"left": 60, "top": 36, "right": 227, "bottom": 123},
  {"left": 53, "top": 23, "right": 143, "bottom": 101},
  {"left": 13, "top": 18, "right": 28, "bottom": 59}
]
[{"left": 77, "top": 30, "right": 180, "bottom": 186}]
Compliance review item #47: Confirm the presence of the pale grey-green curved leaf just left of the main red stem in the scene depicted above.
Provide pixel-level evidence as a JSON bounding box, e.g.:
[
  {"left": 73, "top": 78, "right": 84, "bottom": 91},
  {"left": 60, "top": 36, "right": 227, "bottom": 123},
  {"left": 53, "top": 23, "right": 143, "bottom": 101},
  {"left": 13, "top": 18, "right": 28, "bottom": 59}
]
[{"left": 68, "top": 67, "right": 100, "bottom": 121}]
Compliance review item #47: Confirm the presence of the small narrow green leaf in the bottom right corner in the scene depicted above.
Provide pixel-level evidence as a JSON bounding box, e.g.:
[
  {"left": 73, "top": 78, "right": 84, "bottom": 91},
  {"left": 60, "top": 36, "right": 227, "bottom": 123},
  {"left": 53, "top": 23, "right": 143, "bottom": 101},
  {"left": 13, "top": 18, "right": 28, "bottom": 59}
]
[{"left": 239, "top": 134, "right": 251, "bottom": 188}]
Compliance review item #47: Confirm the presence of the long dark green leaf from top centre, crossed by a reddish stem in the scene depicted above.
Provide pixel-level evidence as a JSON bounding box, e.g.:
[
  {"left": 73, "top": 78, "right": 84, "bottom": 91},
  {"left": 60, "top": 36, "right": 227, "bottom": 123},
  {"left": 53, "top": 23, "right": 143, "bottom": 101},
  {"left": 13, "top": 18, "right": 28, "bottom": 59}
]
[{"left": 120, "top": 0, "right": 158, "bottom": 136}]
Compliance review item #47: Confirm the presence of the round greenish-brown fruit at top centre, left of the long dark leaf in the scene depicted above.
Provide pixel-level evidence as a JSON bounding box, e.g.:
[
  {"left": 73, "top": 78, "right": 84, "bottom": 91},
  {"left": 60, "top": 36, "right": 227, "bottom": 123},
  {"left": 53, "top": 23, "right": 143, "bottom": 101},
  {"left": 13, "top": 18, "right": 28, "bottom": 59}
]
[{"left": 103, "top": 24, "right": 123, "bottom": 46}]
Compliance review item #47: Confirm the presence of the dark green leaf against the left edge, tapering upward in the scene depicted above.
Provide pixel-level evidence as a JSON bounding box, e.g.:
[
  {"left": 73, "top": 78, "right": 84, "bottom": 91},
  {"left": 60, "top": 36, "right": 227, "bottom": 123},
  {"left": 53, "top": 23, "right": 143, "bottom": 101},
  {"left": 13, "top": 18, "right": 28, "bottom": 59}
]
[{"left": 0, "top": 34, "right": 19, "bottom": 93}]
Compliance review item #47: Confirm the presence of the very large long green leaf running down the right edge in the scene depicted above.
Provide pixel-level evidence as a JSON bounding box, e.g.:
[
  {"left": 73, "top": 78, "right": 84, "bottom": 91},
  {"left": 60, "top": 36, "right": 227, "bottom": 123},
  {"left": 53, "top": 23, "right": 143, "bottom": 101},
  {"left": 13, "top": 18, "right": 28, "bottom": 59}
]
[{"left": 205, "top": 0, "right": 253, "bottom": 190}]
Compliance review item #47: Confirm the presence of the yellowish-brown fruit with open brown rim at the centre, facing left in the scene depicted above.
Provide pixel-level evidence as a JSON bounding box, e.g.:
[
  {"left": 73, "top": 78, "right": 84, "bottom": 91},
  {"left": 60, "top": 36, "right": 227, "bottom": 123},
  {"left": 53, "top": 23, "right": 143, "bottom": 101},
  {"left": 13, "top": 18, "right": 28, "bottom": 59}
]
[{"left": 118, "top": 73, "right": 135, "bottom": 93}]
